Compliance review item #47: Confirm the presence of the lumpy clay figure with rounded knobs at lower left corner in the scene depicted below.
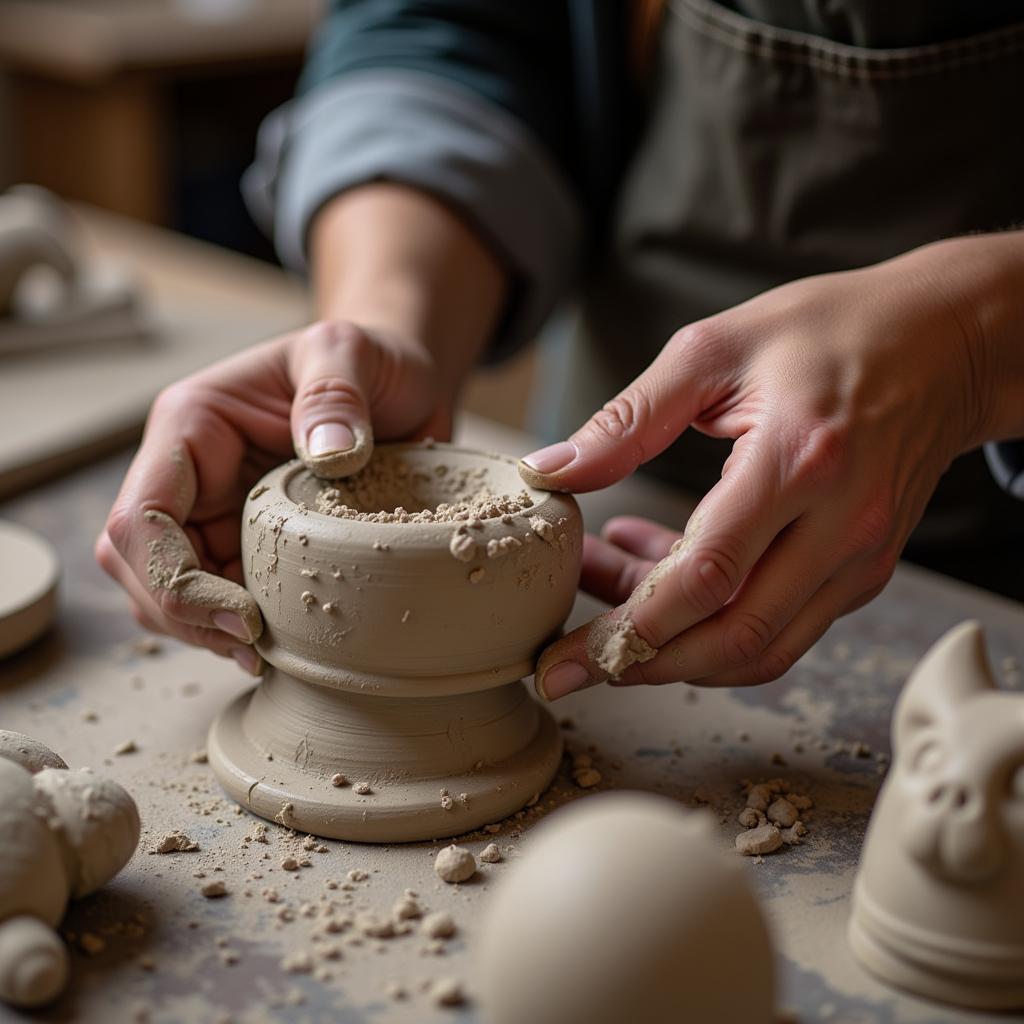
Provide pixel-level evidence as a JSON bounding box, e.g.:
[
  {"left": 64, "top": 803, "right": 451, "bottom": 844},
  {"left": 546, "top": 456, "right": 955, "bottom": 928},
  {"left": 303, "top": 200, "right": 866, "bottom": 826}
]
[{"left": 0, "top": 730, "right": 139, "bottom": 1007}]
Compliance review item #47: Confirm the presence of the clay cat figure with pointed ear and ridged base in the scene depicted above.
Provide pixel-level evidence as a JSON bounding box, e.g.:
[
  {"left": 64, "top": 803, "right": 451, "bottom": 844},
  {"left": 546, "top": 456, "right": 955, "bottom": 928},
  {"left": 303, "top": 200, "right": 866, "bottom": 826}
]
[{"left": 849, "top": 622, "right": 1024, "bottom": 1010}]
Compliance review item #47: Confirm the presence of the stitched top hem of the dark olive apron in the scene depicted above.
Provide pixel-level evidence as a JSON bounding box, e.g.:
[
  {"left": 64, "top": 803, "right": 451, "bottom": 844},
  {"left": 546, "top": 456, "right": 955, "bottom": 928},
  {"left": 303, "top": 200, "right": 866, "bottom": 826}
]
[{"left": 669, "top": 0, "right": 1024, "bottom": 81}]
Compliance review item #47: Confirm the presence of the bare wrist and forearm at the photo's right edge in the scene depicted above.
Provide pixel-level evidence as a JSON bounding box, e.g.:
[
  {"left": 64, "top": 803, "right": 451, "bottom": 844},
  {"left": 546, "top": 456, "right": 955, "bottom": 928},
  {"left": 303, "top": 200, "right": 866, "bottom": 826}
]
[{"left": 906, "top": 230, "right": 1024, "bottom": 446}]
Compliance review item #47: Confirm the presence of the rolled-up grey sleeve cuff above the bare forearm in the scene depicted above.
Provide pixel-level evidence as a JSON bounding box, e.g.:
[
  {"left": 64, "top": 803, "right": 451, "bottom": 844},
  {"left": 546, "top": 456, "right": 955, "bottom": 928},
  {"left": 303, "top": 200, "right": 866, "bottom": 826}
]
[{"left": 243, "top": 69, "right": 583, "bottom": 357}]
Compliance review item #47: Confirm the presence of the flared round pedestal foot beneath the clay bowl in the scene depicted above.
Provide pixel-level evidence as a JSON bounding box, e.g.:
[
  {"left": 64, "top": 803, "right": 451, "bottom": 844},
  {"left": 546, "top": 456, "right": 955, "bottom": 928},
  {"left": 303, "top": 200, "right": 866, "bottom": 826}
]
[{"left": 208, "top": 667, "right": 562, "bottom": 843}]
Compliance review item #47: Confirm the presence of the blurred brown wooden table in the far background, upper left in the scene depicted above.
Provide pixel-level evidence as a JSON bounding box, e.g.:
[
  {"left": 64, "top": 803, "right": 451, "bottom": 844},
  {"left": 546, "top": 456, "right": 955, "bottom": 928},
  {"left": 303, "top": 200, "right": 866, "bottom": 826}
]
[{"left": 0, "top": 0, "right": 323, "bottom": 224}]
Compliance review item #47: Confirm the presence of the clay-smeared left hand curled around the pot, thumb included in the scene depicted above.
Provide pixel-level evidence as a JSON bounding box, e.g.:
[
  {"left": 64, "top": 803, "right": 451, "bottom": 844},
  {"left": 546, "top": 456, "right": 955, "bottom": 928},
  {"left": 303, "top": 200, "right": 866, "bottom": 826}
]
[{"left": 96, "top": 323, "right": 452, "bottom": 675}]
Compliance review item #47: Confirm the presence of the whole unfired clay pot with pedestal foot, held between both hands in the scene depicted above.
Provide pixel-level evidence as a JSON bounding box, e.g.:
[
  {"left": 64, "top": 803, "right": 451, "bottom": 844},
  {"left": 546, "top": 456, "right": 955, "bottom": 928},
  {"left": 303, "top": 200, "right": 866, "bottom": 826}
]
[{"left": 209, "top": 442, "right": 583, "bottom": 842}]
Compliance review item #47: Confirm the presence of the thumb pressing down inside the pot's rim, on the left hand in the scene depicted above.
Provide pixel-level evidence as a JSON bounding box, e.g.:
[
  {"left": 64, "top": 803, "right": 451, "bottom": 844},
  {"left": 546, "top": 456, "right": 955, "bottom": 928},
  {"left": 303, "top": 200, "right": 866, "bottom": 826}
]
[{"left": 289, "top": 323, "right": 377, "bottom": 479}]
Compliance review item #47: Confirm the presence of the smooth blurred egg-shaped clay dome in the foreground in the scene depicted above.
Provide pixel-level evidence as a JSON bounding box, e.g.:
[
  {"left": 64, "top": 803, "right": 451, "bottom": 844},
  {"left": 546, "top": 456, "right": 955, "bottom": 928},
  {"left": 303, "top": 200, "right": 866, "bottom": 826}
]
[{"left": 476, "top": 794, "right": 776, "bottom": 1024}]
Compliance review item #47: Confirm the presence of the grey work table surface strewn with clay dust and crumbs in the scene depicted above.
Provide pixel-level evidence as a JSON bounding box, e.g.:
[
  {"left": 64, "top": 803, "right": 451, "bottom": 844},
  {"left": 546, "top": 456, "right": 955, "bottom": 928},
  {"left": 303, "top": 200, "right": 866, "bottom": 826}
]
[{"left": 0, "top": 409, "right": 1024, "bottom": 1024}]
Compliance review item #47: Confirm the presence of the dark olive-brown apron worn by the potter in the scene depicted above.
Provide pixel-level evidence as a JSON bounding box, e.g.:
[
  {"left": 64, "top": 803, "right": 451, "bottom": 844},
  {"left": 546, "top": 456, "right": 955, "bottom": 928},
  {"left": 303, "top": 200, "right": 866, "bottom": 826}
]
[{"left": 557, "top": 0, "right": 1024, "bottom": 597}]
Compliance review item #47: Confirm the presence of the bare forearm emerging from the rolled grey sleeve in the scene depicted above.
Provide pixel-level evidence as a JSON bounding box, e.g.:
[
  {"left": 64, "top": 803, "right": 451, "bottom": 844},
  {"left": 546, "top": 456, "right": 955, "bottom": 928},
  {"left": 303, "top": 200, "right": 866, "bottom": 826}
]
[{"left": 309, "top": 183, "right": 509, "bottom": 394}]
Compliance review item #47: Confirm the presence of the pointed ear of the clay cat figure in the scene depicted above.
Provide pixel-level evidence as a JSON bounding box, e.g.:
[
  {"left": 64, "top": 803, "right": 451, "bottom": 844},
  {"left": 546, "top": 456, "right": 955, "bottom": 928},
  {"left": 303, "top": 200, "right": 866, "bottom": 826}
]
[{"left": 893, "top": 622, "right": 996, "bottom": 749}]
